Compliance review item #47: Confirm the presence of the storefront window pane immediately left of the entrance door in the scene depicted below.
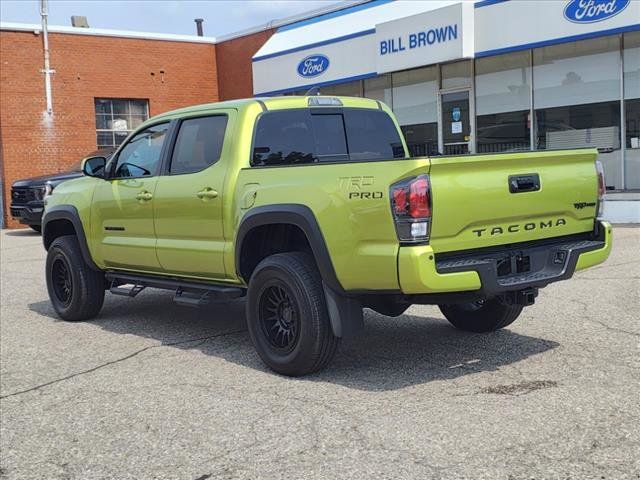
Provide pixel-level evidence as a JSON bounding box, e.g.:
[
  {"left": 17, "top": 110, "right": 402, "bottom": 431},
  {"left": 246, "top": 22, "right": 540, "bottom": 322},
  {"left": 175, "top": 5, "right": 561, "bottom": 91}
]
[{"left": 392, "top": 67, "right": 438, "bottom": 157}]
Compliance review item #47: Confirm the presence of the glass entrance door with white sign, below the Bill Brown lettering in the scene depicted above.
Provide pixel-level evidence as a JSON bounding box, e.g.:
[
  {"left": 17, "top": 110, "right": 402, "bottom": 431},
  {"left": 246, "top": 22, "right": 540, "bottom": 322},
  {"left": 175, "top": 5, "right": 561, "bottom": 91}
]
[{"left": 440, "top": 90, "right": 471, "bottom": 155}]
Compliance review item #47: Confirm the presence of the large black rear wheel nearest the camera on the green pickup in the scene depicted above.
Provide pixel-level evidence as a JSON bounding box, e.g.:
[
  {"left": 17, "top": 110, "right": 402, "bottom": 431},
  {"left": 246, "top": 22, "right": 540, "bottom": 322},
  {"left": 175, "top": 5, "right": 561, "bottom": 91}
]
[{"left": 247, "top": 252, "right": 340, "bottom": 376}]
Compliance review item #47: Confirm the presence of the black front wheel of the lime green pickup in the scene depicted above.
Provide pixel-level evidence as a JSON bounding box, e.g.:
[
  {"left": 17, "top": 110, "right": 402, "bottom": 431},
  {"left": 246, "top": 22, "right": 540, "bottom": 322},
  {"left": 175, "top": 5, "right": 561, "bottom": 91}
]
[{"left": 46, "top": 235, "right": 104, "bottom": 322}]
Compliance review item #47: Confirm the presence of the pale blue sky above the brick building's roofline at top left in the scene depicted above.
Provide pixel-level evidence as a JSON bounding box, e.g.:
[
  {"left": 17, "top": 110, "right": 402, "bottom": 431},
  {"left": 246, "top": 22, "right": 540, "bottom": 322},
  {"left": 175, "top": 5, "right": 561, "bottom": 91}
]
[{"left": 0, "top": 0, "right": 349, "bottom": 37}]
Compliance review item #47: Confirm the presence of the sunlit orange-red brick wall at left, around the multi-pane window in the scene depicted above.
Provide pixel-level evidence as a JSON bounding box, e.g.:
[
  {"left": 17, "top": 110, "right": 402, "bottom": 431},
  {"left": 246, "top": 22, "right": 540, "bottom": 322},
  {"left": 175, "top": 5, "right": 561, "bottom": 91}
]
[{"left": 0, "top": 31, "right": 219, "bottom": 227}]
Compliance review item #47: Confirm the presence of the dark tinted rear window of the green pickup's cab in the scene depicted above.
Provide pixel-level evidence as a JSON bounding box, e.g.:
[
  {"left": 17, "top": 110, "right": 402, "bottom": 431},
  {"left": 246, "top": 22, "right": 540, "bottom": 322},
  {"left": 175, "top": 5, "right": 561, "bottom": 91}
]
[{"left": 251, "top": 108, "right": 405, "bottom": 166}]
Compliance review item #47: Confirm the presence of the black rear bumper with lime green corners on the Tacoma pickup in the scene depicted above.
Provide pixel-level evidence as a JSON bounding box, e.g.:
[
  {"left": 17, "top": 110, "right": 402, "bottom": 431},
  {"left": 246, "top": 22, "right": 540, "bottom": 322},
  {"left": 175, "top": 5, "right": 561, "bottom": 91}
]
[{"left": 398, "top": 222, "right": 611, "bottom": 296}]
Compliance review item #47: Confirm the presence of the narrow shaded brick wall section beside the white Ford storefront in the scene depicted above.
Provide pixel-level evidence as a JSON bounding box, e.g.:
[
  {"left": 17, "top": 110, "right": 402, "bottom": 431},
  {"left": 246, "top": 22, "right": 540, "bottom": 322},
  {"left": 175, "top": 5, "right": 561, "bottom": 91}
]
[{"left": 216, "top": 29, "right": 275, "bottom": 100}]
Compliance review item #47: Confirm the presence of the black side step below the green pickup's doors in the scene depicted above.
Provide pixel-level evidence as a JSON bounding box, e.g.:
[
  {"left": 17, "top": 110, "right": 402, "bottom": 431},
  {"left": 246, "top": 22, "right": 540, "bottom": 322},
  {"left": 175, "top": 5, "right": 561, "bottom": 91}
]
[{"left": 105, "top": 271, "right": 246, "bottom": 307}]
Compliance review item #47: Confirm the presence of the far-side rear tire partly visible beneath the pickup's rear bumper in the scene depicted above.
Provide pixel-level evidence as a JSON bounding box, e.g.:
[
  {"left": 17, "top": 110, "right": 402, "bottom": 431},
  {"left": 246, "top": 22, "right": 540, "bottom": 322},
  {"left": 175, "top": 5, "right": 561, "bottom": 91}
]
[{"left": 438, "top": 298, "right": 524, "bottom": 333}]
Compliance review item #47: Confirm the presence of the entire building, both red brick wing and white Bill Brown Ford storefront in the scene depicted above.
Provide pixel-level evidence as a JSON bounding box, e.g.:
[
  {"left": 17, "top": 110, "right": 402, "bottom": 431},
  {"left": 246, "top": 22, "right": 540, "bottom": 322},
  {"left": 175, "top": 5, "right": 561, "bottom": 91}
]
[{"left": 0, "top": 0, "right": 640, "bottom": 227}]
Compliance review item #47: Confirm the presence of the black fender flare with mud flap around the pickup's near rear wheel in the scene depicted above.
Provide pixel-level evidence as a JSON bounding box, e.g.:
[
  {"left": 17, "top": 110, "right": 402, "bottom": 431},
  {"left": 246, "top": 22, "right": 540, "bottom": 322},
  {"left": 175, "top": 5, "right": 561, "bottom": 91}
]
[{"left": 235, "top": 203, "right": 364, "bottom": 337}]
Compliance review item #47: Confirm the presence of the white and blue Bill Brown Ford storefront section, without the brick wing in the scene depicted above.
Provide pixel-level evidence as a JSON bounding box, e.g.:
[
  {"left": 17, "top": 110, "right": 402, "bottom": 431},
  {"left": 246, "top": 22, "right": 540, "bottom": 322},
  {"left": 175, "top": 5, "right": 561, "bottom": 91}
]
[{"left": 253, "top": 0, "right": 640, "bottom": 221}]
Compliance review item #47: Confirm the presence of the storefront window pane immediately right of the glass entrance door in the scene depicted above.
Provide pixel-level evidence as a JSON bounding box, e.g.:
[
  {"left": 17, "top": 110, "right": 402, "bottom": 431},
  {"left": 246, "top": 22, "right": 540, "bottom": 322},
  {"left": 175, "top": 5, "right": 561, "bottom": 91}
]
[{"left": 475, "top": 51, "right": 531, "bottom": 153}]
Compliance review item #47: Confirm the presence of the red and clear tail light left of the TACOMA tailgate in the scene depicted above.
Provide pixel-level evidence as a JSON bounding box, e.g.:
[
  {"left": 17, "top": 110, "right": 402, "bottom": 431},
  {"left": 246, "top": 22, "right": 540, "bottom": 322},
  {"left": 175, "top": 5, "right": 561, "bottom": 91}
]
[{"left": 389, "top": 175, "right": 431, "bottom": 243}]
